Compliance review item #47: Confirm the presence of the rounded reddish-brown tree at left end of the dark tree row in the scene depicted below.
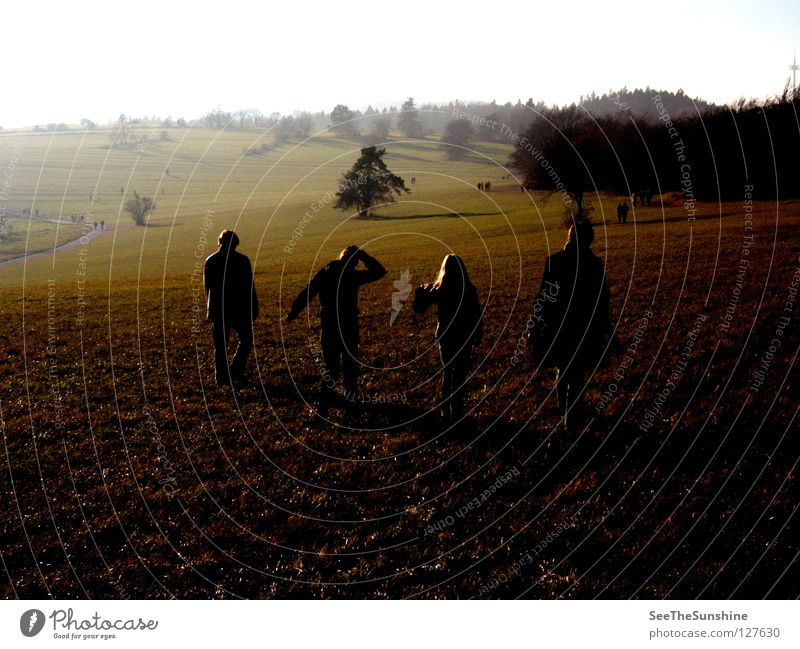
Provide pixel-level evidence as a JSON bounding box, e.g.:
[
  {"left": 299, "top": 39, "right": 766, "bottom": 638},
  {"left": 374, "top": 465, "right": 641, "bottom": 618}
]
[{"left": 509, "top": 105, "right": 609, "bottom": 219}]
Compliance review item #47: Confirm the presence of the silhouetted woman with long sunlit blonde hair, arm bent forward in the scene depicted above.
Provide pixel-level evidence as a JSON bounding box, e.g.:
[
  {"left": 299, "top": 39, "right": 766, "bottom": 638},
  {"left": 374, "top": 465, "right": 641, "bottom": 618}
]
[{"left": 413, "top": 255, "right": 483, "bottom": 422}]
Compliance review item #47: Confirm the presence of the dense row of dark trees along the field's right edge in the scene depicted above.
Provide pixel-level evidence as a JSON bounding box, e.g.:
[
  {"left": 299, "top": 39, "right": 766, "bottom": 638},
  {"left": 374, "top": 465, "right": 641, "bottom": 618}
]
[{"left": 509, "top": 92, "right": 800, "bottom": 209}]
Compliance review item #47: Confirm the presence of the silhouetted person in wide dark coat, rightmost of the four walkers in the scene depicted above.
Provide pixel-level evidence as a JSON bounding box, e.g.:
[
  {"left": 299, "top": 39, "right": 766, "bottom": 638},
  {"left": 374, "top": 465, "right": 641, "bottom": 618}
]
[{"left": 532, "top": 221, "right": 611, "bottom": 426}]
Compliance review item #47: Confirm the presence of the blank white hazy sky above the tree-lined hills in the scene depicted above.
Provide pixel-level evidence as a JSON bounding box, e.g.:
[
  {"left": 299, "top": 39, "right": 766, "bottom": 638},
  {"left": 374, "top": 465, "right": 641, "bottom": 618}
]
[{"left": 0, "top": 0, "right": 800, "bottom": 128}]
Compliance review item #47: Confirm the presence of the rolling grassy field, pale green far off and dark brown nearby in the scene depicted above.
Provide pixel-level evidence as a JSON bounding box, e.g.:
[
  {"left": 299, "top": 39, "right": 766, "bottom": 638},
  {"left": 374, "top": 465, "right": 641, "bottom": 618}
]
[{"left": 0, "top": 126, "right": 800, "bottom": 599}]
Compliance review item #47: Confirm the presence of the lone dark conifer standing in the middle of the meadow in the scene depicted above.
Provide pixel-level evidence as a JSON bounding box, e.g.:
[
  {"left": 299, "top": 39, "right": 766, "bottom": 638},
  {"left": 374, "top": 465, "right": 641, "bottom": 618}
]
[{"left": 334, "top": 146, "right": 411, "bottom": 219}]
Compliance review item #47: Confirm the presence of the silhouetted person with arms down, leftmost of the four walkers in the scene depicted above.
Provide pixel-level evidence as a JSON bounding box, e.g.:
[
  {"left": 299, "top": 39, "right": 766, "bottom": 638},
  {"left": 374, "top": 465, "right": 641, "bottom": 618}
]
[{"left": 203, "top": 230, "right": 258, "bottom": 386}]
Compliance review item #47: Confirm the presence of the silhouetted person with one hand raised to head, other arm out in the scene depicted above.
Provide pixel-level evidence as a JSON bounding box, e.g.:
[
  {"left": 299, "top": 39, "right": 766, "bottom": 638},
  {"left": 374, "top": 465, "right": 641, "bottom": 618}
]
[{"left": 286, "top": 246, "right": 386, "bottom": 405}]
